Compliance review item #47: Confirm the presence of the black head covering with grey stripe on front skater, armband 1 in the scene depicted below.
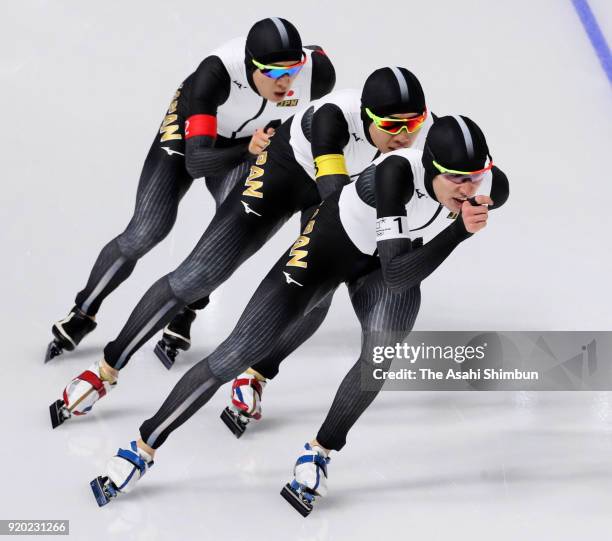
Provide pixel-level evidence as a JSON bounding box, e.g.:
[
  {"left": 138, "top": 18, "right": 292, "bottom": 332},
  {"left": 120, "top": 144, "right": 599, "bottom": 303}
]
[{"left": 422, "top": 115, "right": 489, "bottom": 175}]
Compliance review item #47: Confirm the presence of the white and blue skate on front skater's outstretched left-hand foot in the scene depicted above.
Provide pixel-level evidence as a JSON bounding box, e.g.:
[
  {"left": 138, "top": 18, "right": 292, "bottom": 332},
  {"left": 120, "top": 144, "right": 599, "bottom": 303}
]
[{"left": 89, "top": 441, "right": 153, "bottom": 507}]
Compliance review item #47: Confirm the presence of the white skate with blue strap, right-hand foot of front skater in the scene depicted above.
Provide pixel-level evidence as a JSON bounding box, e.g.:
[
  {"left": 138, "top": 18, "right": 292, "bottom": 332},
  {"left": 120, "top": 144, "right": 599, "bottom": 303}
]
[{"left": 281, "top": 443, "right": 330, "bottom": 517}]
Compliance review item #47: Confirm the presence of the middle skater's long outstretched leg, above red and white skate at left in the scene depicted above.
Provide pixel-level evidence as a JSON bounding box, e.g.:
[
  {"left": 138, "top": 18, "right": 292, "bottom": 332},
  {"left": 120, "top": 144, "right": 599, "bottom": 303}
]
[{"left": 104, "top": 154, "right": 318, "bottom": 369}]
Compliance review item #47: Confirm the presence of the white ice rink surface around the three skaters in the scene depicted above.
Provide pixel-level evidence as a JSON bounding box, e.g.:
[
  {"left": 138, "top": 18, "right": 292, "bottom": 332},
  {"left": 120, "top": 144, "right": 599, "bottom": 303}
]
[{"left": 0, "top": 0, "right": 612, "bottom": 541}]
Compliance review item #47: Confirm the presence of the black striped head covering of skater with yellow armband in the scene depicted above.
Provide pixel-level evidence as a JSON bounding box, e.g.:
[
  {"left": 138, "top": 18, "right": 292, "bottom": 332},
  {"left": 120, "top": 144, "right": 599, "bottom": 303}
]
[{"left": 361, "top": 67, "right": 426, "bottom": 116}]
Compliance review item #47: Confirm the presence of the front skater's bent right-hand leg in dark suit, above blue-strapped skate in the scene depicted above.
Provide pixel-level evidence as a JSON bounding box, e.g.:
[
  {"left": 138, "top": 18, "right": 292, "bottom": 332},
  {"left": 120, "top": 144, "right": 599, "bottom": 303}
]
[{"left": 314, "top": 271, "right": 421, "bottom": 451}]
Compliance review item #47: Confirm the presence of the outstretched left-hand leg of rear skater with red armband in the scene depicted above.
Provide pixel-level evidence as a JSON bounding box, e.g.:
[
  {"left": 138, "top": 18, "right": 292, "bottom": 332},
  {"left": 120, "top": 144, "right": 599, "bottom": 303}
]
[{"left": 75, "top": 141, "right": 192, "bottom": 316}]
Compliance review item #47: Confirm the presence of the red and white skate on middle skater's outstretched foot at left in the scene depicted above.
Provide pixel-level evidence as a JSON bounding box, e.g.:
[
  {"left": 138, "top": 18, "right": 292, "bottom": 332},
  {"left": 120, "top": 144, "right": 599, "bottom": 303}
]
[{"left": 49, "top": 361, "right": 117, "bottom": 428}]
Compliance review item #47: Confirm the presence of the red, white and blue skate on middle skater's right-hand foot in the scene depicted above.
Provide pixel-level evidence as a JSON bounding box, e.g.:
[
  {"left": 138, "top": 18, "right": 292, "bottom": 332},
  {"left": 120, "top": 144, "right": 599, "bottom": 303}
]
[{"left": 221, "top": 368, "right": 266, "bottom": 438}]
